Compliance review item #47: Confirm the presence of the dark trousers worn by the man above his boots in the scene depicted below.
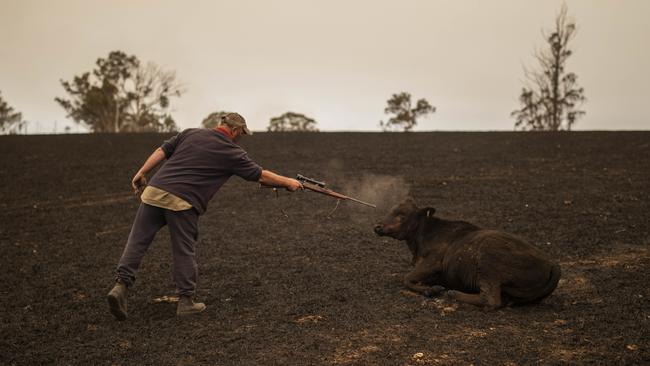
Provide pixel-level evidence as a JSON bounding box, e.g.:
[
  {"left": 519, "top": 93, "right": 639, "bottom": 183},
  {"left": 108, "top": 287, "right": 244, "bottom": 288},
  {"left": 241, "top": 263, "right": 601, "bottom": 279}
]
[{"left": 117, "top": 203, "right": 199, "bottom": 296}]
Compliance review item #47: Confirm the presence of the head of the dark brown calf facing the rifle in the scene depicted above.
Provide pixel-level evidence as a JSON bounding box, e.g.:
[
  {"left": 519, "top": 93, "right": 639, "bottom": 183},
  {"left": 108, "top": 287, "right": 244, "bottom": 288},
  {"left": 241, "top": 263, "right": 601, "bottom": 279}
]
[{"left": 375, "top": 198, "right": 436, "bottom": 240}]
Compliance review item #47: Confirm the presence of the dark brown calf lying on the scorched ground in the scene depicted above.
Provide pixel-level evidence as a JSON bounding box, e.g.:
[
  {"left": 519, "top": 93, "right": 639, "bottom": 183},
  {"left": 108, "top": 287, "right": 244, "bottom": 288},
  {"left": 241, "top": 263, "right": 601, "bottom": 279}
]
[{"left": 375, "top": 199, "right": 560, "bottom": 309}]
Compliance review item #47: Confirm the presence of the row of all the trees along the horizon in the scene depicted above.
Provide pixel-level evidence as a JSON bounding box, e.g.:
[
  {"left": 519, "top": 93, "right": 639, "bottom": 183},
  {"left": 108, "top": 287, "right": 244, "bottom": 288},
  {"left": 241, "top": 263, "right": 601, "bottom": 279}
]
[{"left": 0, "top": 4, "right": 586, "bottom": 133}]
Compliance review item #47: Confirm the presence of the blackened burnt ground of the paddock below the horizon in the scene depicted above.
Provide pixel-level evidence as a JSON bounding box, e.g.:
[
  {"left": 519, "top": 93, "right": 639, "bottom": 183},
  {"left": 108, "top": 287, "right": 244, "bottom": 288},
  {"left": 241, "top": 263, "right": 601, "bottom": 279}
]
[{"left": 0, "top": 132, "right": 650, "bottom": 365}]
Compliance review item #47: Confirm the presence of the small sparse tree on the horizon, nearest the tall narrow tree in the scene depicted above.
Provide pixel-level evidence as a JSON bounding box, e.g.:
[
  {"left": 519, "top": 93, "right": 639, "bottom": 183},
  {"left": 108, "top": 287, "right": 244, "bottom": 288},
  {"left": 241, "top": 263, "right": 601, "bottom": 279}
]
[{"left": 379, "top": 92, "right": 436, "bottom": 132}]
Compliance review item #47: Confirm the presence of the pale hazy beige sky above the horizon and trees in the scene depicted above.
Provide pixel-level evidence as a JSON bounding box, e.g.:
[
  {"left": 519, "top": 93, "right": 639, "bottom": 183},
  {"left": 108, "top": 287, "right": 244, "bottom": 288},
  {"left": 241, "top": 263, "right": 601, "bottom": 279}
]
[{"left": 0, "top": 0, "right": 650, "bottom": 132}]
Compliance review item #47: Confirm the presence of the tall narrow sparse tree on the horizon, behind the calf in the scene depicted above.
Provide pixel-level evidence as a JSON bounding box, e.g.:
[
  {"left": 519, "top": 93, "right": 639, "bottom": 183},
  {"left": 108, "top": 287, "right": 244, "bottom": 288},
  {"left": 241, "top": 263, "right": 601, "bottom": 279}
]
[{"left": 511, "top": 4, "right": 586, "bottom": 131}]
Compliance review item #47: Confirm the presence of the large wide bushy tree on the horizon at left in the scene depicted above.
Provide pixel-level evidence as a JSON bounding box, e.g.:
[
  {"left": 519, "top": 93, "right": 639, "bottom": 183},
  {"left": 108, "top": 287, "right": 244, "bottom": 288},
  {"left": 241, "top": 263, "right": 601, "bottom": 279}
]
[{"left": 55, "top": 51, "right": 183, "bottom": 132}]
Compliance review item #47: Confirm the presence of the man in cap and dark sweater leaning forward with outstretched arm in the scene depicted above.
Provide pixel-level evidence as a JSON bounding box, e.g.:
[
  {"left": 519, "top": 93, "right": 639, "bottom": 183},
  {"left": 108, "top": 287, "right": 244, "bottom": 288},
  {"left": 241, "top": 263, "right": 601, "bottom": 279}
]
[{"left": 108, "top": 113, "right": 302, "bottom": 320}]
